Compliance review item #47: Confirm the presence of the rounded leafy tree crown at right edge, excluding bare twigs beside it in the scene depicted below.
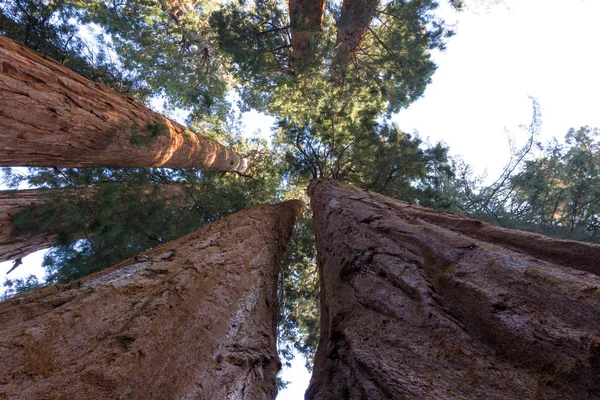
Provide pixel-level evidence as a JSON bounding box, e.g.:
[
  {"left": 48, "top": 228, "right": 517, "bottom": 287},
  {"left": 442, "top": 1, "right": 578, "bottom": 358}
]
[{"left": 507, "top": 127, "right": 600, "bottom": 242}]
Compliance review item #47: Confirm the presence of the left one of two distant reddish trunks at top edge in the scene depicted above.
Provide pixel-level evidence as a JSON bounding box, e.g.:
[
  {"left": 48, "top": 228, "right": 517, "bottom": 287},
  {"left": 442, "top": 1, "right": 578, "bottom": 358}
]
[{"left": 288, "top": 0, "right": 325, "bottom": 72}]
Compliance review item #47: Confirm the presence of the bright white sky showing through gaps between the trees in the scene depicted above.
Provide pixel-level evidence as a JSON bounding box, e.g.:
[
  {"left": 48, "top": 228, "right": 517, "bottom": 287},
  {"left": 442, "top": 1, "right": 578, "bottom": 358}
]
[{"left": 0, "top": 0, "right": 600, "bottom": 400}]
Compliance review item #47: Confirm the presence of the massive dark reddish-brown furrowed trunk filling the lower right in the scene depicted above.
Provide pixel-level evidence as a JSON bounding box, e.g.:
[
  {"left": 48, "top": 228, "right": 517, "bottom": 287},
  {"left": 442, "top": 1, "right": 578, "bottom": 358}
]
[{"left": 306, "top": 180, "right": 600, "bottom": 400}]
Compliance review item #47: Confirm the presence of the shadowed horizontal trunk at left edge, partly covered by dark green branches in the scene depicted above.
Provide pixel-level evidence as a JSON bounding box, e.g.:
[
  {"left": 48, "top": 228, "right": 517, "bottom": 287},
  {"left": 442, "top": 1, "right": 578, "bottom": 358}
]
[{"left": 0, "top": 183, "right": 196, "bottom": 266}]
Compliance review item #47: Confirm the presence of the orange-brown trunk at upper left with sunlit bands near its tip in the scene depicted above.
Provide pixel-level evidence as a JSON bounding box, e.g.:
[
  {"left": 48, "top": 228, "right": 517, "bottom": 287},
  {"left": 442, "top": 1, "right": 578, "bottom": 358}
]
[{"left": 0, "top": 36, "right": 248, "bottom": 173}]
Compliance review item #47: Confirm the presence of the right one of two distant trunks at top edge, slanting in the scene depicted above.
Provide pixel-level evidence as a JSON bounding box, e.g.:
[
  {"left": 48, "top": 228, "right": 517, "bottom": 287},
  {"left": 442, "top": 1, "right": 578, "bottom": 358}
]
[{"left": 332, "top": 0, "right": 379, "bottom": 75}]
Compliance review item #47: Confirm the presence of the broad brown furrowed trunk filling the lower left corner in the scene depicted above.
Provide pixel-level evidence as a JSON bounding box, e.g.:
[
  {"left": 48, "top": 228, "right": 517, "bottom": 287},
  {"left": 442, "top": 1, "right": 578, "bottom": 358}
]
[{"left": 0, "top": 200, "right": 302, "bottom": 400}]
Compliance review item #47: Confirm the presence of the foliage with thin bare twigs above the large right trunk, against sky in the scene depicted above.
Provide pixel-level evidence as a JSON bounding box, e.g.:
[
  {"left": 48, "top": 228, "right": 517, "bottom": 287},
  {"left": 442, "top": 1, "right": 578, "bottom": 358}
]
[{"left": 450, "top": 127, "right": 600, "bottom": 243}]
